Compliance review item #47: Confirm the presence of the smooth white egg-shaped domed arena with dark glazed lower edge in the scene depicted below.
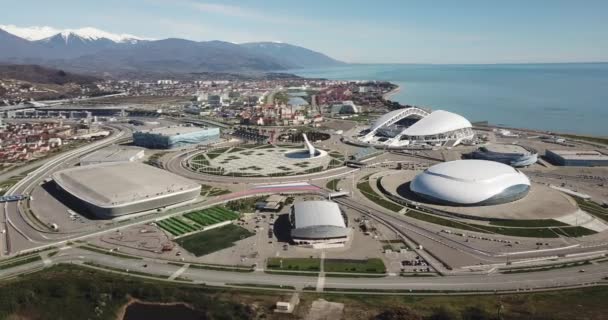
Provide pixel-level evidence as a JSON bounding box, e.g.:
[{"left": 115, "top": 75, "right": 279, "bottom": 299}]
[{"left": 410, "top": 160, "right": 530, "bottom": 206}]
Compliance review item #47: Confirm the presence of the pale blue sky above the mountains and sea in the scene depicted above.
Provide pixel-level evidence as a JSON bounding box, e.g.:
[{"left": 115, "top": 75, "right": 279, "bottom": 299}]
[{"left": 0, "top": 0, "right": 608, "bottom": 63}]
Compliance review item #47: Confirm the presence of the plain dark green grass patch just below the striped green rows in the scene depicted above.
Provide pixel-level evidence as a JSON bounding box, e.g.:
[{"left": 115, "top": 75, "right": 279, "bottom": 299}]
[{"left": 176, "top": 224, "right": 254, "bottom": 257}]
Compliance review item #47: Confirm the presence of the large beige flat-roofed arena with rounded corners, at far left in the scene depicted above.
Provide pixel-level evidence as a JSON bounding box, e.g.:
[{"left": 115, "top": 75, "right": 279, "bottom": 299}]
[{"left": 53, "top": 162, "right": 201, "bottom": 218}]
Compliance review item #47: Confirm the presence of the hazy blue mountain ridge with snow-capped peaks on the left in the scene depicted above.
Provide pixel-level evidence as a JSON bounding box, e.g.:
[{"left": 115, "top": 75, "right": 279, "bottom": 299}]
[{"left": 0, "top": 28, "right": 344, "bottom": 75}]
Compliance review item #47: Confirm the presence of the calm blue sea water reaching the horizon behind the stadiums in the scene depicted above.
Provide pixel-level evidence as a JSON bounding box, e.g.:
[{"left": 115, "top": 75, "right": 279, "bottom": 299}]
[{"left": 289, "top": 63, "right": 608, "bottom": 136}]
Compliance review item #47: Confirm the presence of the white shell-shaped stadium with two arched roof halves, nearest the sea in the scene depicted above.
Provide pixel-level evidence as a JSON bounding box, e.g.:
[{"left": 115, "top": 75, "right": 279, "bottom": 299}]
[{"left": 358, "top": 107, "right": 474, "bottom": 148}]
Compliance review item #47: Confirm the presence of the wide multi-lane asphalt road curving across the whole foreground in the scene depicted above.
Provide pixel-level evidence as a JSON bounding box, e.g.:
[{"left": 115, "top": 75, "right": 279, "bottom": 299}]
[{"left": 0, "top": 247, "right": 608, "bottom": 294}]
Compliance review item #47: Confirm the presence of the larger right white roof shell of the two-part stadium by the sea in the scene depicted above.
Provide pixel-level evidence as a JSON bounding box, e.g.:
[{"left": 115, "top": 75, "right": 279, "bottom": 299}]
[{"left": 401, "top": 110, "right": 471, "bottom": 136}]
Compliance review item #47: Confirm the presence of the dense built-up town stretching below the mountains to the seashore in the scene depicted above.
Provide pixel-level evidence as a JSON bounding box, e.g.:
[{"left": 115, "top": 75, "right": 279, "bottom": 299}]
[{"left": 0, "top": 77, "right": 400, "bottom": 126}]
